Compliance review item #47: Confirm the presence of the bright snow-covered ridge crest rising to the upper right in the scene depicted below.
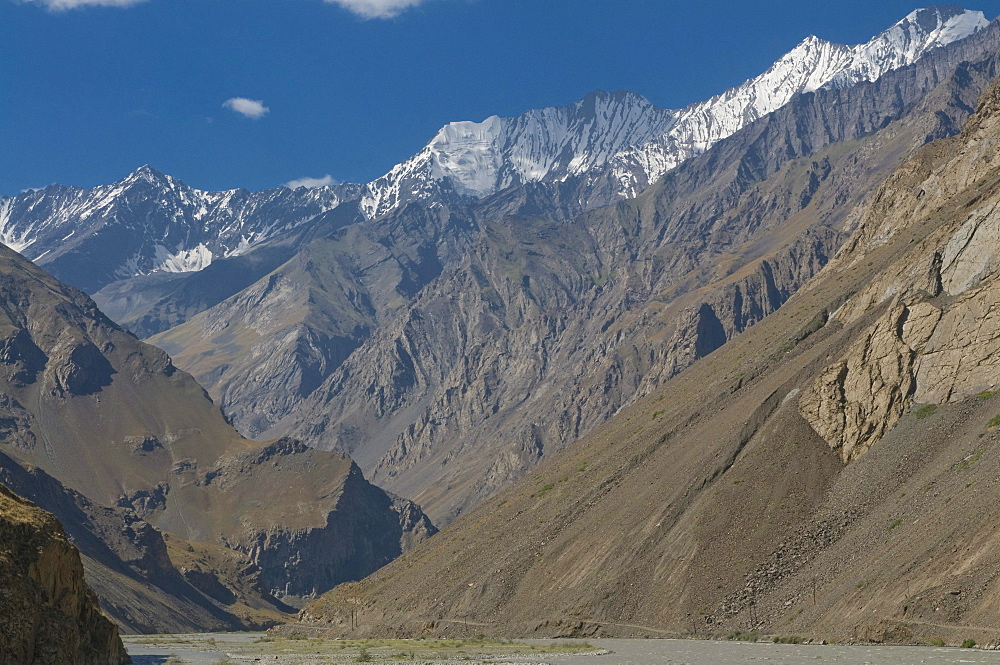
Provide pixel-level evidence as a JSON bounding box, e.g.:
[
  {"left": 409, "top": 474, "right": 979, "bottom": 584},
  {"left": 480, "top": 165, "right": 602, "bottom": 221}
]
[{"left": 362, "top": 5, "right": 989, "bottom": 216}]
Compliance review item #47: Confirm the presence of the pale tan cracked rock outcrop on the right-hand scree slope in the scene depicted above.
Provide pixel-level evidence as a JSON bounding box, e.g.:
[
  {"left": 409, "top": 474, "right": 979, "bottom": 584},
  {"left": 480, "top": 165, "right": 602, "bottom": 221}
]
[{"left": 801, "top": 67, "right": 1000, "bottom": 461}]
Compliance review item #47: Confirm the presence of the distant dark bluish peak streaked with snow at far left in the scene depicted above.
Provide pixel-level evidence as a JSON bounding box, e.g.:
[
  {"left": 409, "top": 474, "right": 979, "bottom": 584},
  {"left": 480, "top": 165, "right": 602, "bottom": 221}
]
[{"left": 0, "top": 165, "right": 360, "bottom": 292}]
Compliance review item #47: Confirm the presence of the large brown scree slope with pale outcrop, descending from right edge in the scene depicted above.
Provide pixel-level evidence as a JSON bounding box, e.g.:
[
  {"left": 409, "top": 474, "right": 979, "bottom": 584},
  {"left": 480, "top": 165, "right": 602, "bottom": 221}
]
[{"left": 302, "top": 75, "right": 1000, "bottom": 644}]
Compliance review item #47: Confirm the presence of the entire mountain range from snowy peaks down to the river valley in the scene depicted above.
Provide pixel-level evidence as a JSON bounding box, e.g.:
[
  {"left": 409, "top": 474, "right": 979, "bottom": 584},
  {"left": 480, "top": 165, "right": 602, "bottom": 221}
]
[{"left": 0, "top": 6, "right": 1000, "bottom": 638}]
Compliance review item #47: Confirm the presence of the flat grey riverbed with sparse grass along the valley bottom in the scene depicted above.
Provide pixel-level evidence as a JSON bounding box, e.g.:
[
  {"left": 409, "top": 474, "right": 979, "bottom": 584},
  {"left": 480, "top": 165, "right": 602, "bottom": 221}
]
[{"left": 124, "top": 633, "right": 1000, "bottom": 665}]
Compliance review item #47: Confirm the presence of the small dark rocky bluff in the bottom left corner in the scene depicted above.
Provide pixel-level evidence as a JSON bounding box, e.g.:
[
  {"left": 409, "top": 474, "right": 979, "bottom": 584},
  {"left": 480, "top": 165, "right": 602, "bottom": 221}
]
[{"left": 0, "top": 486, "right": 130, "bottom": 665}]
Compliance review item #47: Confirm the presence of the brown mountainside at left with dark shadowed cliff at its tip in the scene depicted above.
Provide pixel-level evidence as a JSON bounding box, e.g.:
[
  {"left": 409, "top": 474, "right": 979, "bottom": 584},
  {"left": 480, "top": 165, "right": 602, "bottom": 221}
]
[{"left": 0, "top": 243, "right": 434, "bottom": 630}]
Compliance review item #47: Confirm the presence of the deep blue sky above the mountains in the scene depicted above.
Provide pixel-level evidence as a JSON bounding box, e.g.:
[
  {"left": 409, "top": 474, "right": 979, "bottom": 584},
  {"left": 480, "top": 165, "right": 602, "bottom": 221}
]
[{"left": 0, "top": 0, "right": 1000, "bottom": 194}]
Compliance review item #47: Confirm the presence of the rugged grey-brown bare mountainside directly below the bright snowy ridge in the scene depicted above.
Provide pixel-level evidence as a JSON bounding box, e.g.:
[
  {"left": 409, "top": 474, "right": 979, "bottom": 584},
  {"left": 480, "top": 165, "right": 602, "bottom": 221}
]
[{"left": 272, "top": 25, "right": 1000, "bottom": 522}]
